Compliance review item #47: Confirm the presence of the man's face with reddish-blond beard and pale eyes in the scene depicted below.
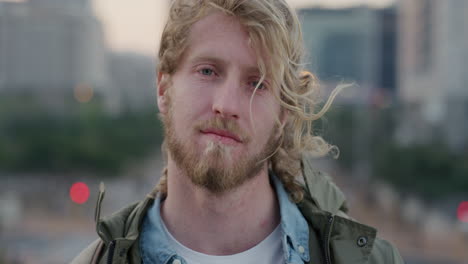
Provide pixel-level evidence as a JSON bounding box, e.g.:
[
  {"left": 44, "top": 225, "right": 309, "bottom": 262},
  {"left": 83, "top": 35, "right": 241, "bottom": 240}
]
[{"left": 158, "top": 12, "right": 280, "bottom": 193}]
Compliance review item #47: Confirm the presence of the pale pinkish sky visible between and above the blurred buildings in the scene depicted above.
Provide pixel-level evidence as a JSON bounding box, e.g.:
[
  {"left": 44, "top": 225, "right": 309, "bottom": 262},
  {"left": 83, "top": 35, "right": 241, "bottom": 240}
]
[{"left": 93, "top": 0, "right": 393, "bottom": 56}]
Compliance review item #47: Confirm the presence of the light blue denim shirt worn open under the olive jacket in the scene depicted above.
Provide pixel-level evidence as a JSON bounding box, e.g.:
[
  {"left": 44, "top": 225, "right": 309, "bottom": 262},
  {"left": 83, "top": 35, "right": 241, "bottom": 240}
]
[{"left": 140, "top": 176, "right": 310, "bottom": 264}]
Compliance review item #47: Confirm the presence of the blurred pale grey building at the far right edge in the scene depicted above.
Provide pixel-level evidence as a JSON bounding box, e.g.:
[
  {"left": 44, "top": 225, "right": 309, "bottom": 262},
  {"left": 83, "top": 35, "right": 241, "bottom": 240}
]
[{"left": 397, "top": 0, "right": 468, "bottom": 150}]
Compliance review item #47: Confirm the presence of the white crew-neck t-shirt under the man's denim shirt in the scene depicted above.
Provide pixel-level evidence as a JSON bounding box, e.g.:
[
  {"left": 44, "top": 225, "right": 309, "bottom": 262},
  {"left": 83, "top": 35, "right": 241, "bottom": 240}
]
[{"left": 163, "top": 220, "right": 285, "bottom": 264}]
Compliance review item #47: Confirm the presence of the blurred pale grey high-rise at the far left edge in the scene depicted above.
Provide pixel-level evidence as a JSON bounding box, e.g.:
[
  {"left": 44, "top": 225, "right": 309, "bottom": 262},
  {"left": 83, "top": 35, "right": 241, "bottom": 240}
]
[{"left": 0, "top": 0, "right": 110, "bottom": 109}]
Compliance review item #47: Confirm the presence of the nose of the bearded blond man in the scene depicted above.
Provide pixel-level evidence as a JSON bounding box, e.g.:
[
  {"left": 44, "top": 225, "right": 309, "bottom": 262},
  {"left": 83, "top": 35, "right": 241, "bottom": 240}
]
[{"left": 213, "top": 78, "right": 242, "bottom": 119}]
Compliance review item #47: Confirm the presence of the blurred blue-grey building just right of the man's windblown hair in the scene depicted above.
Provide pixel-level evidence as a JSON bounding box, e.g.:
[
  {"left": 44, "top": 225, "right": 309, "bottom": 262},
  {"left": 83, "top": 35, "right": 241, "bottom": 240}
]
[{"left": 299, "top": 6, "right": 396, "bottom": 103}]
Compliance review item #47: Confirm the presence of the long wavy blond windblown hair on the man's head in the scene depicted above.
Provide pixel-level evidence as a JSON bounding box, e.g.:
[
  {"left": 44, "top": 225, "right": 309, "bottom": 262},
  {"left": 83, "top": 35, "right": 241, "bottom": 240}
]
[{"left": 158, "top": 0, "right": 340, "bottom": 202}]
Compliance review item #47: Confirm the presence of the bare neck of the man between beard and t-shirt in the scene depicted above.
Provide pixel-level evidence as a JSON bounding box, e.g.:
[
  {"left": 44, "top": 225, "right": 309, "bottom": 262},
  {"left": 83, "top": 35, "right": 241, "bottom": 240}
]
[{"left": 161, "top": 160, "right": 280, "bottom": 255}]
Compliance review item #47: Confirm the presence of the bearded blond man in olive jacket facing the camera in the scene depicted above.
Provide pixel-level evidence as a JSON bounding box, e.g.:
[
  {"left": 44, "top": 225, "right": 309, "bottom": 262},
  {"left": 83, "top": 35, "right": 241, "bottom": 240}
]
[{"left": 73, "top": 0, "right": 403, "bottom": 264}]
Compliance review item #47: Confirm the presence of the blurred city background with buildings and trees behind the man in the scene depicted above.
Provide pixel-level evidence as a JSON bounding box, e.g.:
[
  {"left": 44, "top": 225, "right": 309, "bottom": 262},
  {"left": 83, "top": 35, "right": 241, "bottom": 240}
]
[{"left": 0, "top": 0, "right": 468, "bottom": 264}]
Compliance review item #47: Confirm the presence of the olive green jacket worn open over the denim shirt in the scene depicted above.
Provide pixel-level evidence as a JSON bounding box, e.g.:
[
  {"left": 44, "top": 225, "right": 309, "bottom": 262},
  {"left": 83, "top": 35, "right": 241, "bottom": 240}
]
[{"left": 71, "top": 158, "right": 404, "bottom": 264}]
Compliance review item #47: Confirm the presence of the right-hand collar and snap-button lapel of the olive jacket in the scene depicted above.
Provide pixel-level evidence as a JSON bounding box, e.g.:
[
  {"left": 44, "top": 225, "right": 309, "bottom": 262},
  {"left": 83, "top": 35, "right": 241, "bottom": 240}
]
[{"left": 298, "top": 156, "right": 377, "bottom": 264}]
